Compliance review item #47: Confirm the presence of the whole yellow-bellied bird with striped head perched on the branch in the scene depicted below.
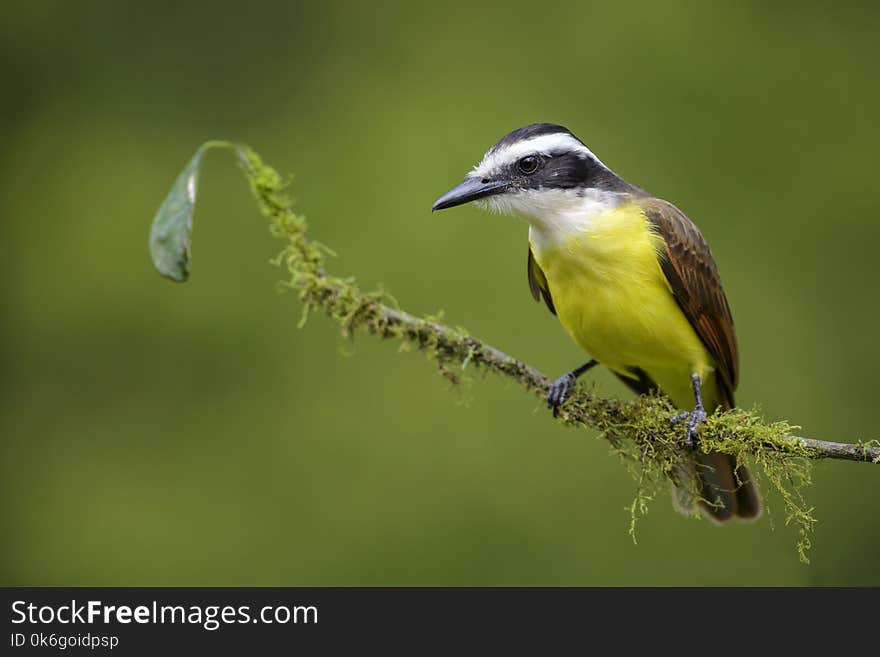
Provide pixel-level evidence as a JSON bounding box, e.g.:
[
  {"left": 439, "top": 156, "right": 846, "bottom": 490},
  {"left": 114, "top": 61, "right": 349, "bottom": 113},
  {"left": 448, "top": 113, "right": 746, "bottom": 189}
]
[{"left": 433, "top": 123, "right": 761, "bottom": 522}]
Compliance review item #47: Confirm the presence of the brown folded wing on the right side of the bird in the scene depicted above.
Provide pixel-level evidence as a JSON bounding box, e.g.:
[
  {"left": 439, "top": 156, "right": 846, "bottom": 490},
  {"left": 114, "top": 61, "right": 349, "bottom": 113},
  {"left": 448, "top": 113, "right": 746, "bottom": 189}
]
[{"left": 642, "top": 199, "right": 739, "bottom": 406}]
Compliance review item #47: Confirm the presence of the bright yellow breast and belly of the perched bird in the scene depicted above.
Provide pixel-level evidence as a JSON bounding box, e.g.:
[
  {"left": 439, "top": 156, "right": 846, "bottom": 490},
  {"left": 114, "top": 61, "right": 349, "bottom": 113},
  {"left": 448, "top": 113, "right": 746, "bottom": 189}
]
[{"left": 530, "top": 202, "right": 715, "bottom": 407}]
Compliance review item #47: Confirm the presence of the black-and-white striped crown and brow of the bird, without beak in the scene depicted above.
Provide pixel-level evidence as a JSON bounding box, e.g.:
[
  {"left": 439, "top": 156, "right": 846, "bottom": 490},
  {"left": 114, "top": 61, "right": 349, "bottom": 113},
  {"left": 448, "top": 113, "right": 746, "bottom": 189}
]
[{"left": 469, "top": 123, "right": 606, "bottom": 187}]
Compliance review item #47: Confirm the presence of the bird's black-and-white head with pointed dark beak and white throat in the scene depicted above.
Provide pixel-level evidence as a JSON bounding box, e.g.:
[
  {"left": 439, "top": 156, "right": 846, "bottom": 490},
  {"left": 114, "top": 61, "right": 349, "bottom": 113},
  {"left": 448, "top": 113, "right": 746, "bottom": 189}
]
[{"left": 432, "top": 123, "right": 629, "bottom": 219}]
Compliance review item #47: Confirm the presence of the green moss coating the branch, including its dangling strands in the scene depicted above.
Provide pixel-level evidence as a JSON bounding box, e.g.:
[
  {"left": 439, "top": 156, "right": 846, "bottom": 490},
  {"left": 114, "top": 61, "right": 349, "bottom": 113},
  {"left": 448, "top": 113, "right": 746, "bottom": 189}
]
[{"left": 242, "top": 149, "right": 816, "bottom": 562}]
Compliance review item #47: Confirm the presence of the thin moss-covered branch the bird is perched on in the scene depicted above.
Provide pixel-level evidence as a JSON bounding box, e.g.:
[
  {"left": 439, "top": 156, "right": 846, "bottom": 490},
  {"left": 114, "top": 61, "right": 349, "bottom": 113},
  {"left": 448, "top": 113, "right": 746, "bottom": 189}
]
[{"left": 245, "top": 151, "right": 880, "bottom": 463}]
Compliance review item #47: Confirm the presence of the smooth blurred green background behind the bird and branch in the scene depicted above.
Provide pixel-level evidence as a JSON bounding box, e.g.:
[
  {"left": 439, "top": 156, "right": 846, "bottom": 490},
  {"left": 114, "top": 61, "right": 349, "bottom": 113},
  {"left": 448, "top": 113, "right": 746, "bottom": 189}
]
[{"left": 0, "top": 0, "right": 880, "bottom": 585}]
